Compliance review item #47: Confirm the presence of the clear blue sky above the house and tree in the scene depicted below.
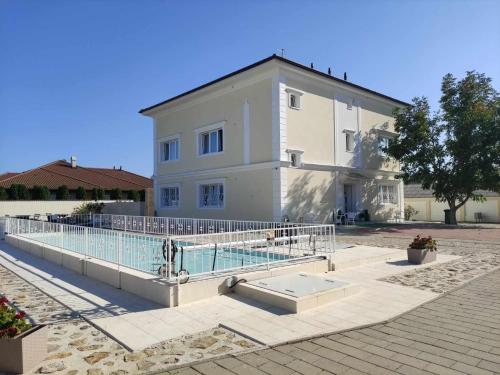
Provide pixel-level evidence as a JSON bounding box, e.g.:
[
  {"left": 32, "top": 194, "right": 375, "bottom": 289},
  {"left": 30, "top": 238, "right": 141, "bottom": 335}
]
[{"left": 0, "top": 0, "right": 500, "bottom": 176}]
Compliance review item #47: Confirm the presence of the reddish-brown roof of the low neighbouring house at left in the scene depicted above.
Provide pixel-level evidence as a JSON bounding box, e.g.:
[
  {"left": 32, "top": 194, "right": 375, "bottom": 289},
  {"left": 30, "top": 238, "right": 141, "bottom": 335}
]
[{"left": 0, "top": 160, "right": 153, "bottom": 190}]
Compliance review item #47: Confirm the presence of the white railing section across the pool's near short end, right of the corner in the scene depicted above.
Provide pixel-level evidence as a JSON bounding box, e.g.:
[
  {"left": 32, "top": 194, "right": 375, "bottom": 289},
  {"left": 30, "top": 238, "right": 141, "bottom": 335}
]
[{"left": 166, "top": 225, "right": 335, "bottom": 278}]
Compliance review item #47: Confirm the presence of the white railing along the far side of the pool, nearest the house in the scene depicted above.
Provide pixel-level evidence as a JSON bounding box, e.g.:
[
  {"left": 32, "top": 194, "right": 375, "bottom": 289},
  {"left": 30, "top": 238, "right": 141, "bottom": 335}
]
[{"left": 47, "top": 214, "right": 314, "bottom": 236}]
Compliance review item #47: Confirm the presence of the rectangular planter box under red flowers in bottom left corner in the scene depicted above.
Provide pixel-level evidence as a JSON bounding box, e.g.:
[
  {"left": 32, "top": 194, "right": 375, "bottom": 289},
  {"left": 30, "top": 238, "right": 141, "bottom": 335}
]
[{"left": 0, "top": 325, "right": 48, "bottom": 374}]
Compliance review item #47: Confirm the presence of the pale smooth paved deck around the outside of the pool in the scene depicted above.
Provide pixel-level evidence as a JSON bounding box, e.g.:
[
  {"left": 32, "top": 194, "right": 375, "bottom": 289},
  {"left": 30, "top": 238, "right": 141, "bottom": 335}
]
[{"left": 0, "top": 241, "right": 459, "bottom": 350}]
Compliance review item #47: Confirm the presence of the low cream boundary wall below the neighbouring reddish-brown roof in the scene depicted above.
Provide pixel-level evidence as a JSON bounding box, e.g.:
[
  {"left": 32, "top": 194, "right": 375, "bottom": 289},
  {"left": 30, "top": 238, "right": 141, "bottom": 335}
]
[{"left": 0, "top": 201, "right": 144, "bottom": 216}]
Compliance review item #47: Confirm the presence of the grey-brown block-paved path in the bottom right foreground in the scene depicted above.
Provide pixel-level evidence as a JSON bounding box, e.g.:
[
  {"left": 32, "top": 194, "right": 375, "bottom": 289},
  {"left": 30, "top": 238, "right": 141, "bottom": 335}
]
[{"left": 164, "top": 270, "right": 500, "bottom": 375}]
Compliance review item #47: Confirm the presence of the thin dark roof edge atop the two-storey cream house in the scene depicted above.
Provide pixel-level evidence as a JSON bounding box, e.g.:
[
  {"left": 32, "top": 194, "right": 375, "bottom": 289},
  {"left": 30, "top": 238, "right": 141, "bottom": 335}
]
[{"left": 139, "top": 55, "right": 410, "bottom": 113}]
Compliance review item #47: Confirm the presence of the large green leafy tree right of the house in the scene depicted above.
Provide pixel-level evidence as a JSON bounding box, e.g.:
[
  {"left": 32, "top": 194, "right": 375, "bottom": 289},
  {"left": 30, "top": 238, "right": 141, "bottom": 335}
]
[{"left": 386, "top": 71, "right": 500, "bottom": 224}]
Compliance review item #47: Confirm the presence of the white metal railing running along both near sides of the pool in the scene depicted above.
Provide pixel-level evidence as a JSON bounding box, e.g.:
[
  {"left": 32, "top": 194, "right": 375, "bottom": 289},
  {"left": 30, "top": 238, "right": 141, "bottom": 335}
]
[{"left": 5, "top": 217, "right": 335, "bottom": 282}]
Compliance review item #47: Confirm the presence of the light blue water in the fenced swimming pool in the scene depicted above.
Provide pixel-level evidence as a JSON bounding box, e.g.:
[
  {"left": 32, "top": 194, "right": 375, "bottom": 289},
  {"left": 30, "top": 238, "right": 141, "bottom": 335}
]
[{"left": 30, "top": 231, "right": 290, "bottom": 275}]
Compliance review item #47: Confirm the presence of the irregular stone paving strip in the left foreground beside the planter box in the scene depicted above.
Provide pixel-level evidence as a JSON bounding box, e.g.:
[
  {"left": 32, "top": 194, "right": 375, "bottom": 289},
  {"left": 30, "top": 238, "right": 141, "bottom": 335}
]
[{"left": 0, "top": 266, "right": 258, "bottom": 375}]
